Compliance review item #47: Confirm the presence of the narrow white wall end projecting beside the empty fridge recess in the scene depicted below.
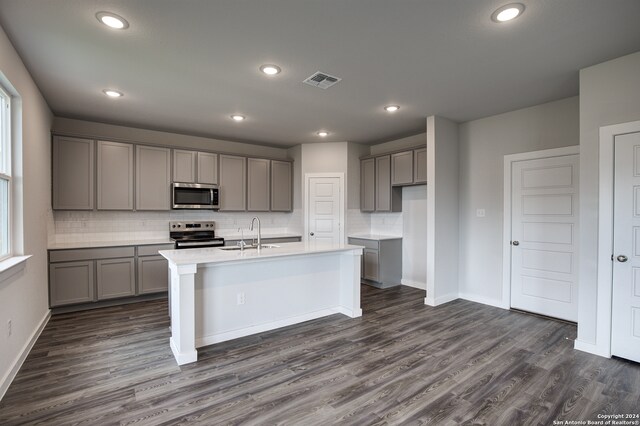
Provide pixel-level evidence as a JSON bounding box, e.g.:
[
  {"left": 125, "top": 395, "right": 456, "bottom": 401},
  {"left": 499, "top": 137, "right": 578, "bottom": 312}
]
[{"left": 425, "top": 116, "right": 459, "bottom": 306}]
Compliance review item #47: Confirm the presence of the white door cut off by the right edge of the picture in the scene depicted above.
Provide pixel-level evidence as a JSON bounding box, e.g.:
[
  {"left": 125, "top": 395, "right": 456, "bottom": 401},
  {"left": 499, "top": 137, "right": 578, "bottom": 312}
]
[{"left": 611, "top": 133, "right": 640, "bottom": 362}]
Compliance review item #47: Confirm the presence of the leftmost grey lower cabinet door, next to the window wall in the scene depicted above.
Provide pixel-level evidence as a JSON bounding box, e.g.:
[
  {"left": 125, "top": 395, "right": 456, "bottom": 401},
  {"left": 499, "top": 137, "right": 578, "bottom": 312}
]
[{"left": 49, "top": 260, "right": 94, "bottom": 308}]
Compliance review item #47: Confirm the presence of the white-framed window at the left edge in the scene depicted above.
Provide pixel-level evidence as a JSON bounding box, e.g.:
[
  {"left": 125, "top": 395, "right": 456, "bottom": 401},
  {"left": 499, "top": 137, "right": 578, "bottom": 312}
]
[{"left": 0, "top": 84, "right": 13, "bottom": 261}]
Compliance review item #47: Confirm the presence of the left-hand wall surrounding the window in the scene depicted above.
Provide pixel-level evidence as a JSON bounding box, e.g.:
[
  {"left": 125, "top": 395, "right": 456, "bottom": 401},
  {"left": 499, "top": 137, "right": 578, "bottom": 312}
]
[{"left": 0, "top": 24, "right": 53, "bottom": 397}]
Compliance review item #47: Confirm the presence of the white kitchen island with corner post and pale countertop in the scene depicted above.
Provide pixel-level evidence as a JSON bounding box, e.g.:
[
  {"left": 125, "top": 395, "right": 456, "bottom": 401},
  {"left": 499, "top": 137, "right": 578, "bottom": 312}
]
[{"left": 160, "top": 242, "right": 362, "bottom": 365}]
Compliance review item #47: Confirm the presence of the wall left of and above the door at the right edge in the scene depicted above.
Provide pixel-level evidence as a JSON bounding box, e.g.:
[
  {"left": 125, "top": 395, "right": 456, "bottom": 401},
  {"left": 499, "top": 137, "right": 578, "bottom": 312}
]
[{"left": 577, "top": 52, "right": 640, "bottom": 353}]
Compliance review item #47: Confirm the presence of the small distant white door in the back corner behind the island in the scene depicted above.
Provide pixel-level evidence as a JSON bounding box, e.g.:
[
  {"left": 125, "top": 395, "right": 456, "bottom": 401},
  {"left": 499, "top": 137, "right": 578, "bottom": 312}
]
[{"left": 307, "top": 177, "right": 343, "bottom": 244}]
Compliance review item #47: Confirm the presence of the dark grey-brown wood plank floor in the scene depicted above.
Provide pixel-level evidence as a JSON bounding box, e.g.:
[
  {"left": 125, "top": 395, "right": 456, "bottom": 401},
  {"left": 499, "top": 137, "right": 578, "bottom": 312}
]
[{"left": 0, "top": 286, "right": 640, "bottom": 426}]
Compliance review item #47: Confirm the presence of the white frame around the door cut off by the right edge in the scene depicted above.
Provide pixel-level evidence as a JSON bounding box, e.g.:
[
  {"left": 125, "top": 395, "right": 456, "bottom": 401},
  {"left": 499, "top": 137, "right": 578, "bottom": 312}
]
[{"left": 575, "top": 121, "right": 640, "bottom": 357}]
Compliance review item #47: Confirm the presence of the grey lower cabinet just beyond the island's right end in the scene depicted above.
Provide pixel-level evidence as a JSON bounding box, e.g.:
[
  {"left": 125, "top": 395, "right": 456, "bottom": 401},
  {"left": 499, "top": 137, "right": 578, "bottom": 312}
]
[{"left": 349, "top": 237, "right": 402, "bottom": 288}]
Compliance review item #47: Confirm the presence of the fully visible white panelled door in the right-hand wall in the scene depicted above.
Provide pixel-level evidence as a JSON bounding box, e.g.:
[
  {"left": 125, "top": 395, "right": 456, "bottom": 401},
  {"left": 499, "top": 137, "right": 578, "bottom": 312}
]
[{"left": 511, "top": 155, "right": 579, "bottom": 321}]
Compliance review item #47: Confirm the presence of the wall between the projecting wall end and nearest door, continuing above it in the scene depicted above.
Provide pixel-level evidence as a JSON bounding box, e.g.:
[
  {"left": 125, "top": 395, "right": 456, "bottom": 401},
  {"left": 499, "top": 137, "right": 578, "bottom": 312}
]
[{"left": 459, "top": 97, "right": 579, "bottom": 306}]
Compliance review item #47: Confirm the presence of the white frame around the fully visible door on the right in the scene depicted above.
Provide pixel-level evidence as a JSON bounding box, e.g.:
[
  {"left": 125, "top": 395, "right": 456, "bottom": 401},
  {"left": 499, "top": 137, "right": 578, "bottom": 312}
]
[{"left": 500, "top": 145, "right": 580, "bottom": 309}]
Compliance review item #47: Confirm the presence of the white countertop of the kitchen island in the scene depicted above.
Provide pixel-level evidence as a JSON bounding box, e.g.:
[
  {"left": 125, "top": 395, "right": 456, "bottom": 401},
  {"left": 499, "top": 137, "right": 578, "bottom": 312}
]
[{"left": 159, "top": 242, "right": 362, "bottom": 265}]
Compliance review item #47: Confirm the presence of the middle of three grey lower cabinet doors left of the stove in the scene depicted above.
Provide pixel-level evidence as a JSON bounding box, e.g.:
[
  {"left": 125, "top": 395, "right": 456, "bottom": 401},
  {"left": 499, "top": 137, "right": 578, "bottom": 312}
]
[{"left": 96, "top": 257, "right": 136, "bottom": 300}]
